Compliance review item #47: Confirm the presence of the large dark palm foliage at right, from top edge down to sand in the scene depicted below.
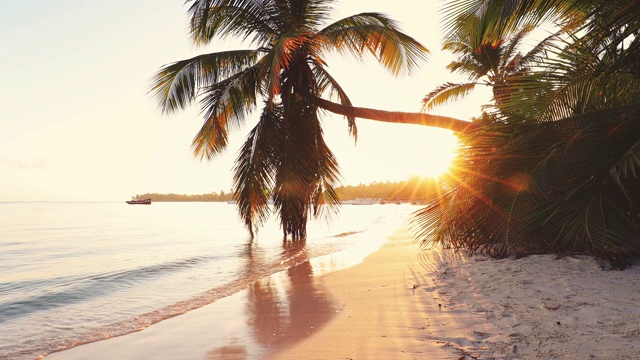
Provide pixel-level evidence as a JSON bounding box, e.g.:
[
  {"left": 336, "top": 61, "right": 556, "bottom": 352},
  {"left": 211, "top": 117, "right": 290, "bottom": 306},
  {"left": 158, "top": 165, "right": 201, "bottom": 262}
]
[{"left": 414, "top": 0, "right": 640, "bottom": 268}]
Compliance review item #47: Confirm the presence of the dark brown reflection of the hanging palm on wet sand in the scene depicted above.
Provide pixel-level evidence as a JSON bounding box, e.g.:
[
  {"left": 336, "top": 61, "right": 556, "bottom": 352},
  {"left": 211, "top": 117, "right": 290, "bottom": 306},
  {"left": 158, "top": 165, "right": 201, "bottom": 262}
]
[{"left": 208, "top": 241, "right": 336, "bottom": 360}]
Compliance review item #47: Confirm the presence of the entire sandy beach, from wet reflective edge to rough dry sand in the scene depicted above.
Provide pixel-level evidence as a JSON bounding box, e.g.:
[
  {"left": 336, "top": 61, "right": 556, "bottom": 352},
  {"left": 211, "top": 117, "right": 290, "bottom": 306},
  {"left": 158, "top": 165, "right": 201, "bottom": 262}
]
[{"left": 47, "top": 226, "right": 640, "bottom": 360}]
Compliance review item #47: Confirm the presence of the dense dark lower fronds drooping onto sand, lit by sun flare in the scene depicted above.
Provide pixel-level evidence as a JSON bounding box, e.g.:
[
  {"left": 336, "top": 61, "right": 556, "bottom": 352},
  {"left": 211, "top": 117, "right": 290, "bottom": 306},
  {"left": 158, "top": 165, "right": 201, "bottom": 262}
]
[{"left": 414, "top": 105, "right": 640, "bottom": 268}]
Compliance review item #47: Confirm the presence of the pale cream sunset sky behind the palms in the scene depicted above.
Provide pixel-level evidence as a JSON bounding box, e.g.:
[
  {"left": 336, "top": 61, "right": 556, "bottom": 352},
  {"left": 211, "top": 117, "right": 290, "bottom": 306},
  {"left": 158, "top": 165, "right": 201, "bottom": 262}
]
[{"left": 0, "top": 0, "right": 488, "bottom": 201}]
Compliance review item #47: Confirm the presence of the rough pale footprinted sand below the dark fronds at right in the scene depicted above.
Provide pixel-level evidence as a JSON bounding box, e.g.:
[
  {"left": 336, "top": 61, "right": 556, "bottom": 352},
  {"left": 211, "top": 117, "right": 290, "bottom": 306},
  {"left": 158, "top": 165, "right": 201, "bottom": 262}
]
[{"left": 429, "top": 251, "right": 640, "bottom": 359}]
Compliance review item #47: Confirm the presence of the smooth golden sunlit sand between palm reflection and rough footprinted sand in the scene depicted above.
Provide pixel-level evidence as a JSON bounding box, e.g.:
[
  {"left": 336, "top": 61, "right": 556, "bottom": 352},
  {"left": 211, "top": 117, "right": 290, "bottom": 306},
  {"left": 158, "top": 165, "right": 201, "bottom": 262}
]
[{"left": 269, "top": 228, "right": 459, "bottom": 360}]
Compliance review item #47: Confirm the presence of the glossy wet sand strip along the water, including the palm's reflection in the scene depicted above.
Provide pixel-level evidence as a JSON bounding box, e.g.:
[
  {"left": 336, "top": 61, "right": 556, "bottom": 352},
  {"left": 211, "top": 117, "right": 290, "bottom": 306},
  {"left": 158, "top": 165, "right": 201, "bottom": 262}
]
[{"left": 47, "top": 236, "right": 375, "bottom": 360}]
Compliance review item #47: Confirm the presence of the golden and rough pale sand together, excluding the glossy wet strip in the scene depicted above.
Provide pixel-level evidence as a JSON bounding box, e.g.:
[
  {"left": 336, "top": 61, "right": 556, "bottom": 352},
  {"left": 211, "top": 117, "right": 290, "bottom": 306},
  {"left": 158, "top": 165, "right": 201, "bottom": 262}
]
[{"left": 272, "top": 232, "right": 640, "bottom": 359}]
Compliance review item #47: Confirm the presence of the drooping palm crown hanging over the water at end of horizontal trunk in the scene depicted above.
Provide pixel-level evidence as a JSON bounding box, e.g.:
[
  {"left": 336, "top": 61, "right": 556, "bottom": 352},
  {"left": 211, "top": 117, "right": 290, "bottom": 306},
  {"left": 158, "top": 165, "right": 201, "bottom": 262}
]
[{"left": 151, "top": 0, "right": 437, "bottom": 240}]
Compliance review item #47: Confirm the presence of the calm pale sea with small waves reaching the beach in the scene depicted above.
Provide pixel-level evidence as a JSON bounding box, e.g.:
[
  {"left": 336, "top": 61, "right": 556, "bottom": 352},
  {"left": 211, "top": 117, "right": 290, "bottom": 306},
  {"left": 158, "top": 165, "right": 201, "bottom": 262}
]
[{"left": 0, "top": 202, "right": 416, "bottom": 359}]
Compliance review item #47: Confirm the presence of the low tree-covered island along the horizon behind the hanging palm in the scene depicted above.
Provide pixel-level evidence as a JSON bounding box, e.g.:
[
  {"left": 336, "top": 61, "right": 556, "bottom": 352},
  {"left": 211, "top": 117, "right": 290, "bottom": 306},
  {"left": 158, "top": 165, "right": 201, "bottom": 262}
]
[{"left": 132, "top": 176, "right": 436, "bottom": 202}]
